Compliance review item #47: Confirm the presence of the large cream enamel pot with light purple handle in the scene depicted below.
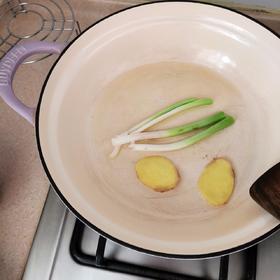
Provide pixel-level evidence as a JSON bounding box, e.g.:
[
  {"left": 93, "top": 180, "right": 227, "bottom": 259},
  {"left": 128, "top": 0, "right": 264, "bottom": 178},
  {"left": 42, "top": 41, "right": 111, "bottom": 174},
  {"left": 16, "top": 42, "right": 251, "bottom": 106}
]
[{"left": 0, "top": 1, "right": 280, "bottom": 258}]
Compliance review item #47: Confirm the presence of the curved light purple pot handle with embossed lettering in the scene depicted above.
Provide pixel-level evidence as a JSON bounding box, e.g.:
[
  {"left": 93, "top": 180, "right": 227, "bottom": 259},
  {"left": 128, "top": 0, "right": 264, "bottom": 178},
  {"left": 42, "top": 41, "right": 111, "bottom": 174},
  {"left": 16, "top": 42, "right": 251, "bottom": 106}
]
[{"left": 0, "top": 41, "right": 65, "bottom": 124}]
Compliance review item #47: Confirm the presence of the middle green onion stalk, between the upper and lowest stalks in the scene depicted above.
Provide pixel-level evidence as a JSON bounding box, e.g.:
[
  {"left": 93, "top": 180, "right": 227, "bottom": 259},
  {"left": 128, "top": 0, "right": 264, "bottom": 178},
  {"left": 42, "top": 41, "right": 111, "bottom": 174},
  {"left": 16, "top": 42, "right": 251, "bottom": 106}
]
[{"left": 112, "top": 112, "right": 226, "bottom": 146}]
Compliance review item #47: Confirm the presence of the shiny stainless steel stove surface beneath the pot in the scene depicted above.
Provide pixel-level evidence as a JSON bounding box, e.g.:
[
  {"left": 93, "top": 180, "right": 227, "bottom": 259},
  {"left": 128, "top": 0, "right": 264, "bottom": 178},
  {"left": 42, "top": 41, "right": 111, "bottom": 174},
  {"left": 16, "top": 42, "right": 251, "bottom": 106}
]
[{"left": 23, "top": 189, "right": 280, "bottom": 280}]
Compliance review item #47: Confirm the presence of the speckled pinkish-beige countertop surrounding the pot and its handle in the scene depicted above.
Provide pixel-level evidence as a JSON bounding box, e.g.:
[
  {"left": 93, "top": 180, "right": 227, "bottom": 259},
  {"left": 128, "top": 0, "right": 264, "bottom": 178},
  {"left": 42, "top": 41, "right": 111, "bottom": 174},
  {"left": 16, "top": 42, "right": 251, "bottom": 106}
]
[{"left": 0, "top": 0, "right": 280, "bottom": 280}]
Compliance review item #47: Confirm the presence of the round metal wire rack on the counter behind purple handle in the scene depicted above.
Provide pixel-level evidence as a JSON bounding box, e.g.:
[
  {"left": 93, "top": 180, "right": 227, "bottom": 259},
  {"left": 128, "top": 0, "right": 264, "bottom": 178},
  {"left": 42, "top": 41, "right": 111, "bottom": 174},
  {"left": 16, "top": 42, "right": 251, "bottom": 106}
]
[{"left": 0, "top": 0, "right": 81, "bottom": 63}]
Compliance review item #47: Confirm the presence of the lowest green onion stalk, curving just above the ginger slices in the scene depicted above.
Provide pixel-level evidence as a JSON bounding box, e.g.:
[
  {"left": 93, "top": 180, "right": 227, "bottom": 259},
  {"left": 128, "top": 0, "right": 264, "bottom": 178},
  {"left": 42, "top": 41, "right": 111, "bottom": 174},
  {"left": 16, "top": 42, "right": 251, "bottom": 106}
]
[{"left": 129, "top": 115, "right": 234, "bottom": 152}]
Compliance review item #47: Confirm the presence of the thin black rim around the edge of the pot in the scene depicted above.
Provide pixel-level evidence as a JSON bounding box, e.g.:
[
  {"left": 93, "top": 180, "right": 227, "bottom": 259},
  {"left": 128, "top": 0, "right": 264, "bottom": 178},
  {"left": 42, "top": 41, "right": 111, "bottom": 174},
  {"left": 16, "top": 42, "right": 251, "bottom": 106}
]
[{"left": 35, "top": 0, "right": 280, "bottom": 259}]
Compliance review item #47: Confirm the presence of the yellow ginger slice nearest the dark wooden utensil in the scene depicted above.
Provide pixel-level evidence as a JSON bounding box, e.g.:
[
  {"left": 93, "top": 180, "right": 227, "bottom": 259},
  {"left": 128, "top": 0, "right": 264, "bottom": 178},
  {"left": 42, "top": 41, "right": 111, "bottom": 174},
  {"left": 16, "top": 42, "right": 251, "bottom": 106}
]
[{"left": 198, "top": 158, "right": 234, "bottom": 206}]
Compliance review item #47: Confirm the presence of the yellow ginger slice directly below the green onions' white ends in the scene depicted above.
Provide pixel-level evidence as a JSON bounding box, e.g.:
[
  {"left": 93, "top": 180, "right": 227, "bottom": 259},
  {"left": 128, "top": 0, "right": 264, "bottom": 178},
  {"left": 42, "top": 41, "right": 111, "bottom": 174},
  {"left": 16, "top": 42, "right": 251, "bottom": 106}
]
[{"left": 135, "top": 156, "right": 180, "bottom": 192}]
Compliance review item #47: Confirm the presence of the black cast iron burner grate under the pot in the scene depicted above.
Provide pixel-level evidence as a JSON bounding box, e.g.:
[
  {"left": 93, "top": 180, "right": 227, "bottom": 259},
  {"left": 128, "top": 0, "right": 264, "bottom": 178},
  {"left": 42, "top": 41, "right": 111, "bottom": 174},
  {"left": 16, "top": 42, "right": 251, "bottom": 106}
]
[{"left": 70, "top": 220, "right": 257, "bottom": 280}]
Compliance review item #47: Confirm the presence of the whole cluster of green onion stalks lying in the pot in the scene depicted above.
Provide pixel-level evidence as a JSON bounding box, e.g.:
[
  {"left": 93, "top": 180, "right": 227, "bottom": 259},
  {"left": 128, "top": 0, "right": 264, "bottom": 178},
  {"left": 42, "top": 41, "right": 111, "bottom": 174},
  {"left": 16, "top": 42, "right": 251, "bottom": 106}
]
[{"left": 111, "top": 98, "right": 235, "bottom": 157}]
